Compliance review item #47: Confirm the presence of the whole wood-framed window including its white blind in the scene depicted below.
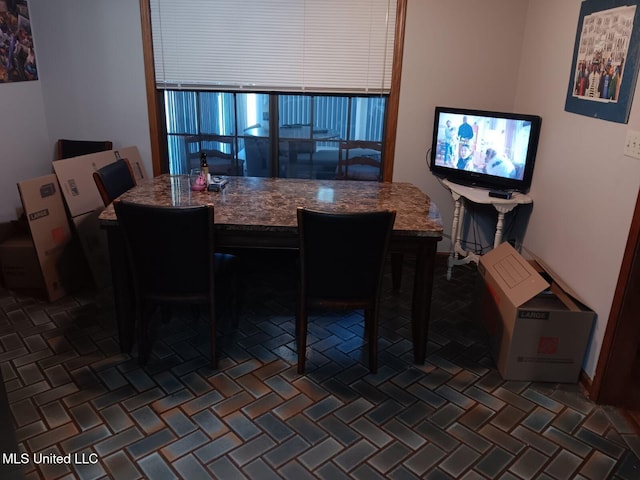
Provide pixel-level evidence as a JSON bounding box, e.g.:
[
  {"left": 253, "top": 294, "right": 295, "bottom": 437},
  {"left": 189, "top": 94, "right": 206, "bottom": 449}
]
[{"left": 141, "top": 0, "right": 406, "bottom": 180}]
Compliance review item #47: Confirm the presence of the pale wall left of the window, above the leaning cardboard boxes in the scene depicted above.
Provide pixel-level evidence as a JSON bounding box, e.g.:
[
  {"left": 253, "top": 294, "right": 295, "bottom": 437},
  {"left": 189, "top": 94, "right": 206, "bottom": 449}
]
[{"left": 0, "top": 0, "right": 152, "bottom": 222}]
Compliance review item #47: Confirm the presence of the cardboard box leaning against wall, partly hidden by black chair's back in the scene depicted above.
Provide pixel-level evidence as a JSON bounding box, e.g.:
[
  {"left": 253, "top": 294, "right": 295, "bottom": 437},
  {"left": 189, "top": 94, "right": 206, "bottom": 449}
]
[{"left": 53, "top": 146, "right": 146, "bottom": 288}]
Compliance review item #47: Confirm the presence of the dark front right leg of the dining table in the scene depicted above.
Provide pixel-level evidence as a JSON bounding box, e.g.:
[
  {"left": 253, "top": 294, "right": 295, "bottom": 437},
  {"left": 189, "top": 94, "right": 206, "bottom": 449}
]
[{"left": 411, "top": 240, "right": 437, "bottom": 365}]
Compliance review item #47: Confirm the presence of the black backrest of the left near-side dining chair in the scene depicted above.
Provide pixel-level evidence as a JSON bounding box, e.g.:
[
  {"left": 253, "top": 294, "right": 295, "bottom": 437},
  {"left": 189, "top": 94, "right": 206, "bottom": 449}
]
[{"left": 113, "top": 200, "right": 215, "bottom": 302}]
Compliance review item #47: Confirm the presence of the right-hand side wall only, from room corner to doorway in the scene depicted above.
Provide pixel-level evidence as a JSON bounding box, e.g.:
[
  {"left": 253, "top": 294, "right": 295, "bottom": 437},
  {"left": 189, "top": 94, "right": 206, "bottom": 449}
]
[{"left": 516, "top": 0, "right": 640, "bottom": 378}]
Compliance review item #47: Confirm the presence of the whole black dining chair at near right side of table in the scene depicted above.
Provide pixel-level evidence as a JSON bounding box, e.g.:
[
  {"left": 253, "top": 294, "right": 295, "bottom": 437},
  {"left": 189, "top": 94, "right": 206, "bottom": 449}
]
[{"left": 296, "top": 207, "right": 396, "bottom": 373}]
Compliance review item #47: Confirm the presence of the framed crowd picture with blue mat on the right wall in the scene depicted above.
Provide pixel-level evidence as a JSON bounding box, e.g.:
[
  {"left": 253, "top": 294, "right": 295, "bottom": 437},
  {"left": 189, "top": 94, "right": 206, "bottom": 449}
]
[{"left": 564, "top": 0, "right": 640, "bottom": 123}]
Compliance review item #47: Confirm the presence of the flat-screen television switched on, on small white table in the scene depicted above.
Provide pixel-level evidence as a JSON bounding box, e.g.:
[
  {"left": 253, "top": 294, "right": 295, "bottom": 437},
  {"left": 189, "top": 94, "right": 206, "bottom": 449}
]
[{"left": 429, "top": 107, "right": 542, "bottom": 193}]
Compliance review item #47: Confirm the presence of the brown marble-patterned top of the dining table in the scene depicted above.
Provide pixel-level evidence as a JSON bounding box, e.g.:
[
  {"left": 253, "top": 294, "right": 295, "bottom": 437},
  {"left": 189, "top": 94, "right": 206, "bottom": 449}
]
[{"left": 99, "top": 174, "right": 443, "bottom": 237}]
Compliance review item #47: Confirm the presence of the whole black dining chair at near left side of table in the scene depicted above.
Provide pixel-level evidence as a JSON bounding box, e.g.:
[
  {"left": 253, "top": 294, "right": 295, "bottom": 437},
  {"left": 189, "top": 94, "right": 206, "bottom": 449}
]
[{"left": 113, "top": 200, "right": 237, "bottom": 368}]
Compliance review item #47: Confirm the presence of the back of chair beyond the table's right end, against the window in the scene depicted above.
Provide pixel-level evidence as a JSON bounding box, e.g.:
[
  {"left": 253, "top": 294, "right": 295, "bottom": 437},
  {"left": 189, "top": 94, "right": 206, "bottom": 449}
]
[{"left": 336, "top": 141, "right": 382, "bottom": 181}]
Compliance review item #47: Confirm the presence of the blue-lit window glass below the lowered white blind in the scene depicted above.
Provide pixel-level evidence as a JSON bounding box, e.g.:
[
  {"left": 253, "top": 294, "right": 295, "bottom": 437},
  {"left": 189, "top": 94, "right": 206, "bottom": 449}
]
[{"left": 164, "top": 90, "right": 387, "bottom": 179}]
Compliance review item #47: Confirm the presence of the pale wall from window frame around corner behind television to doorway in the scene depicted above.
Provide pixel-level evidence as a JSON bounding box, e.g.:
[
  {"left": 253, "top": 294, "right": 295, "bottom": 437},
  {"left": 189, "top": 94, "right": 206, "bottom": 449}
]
[{"left": 394, "top": 0, "right": 640, "bottom": 378}]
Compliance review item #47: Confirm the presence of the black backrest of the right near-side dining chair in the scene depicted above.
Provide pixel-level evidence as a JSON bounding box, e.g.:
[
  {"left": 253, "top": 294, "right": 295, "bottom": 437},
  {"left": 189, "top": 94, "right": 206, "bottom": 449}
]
[{"left": 298, "top": 207, "right": 396, "bottom": 302}]
